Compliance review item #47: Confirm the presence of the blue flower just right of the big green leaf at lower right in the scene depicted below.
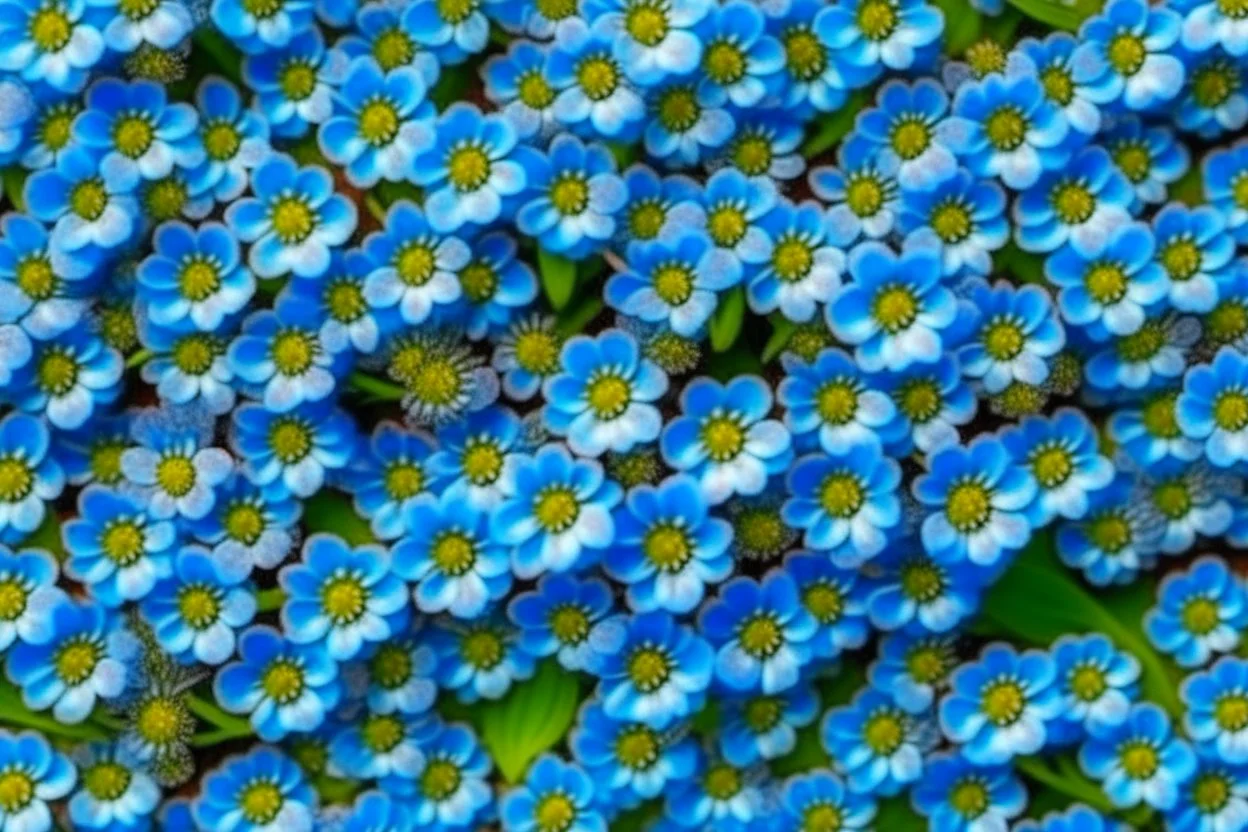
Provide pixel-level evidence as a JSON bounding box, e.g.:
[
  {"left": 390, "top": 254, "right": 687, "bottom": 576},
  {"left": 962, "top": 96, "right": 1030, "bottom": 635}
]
[{"left": 1144, "top": 556, "right": 1248, "bottom": 667}]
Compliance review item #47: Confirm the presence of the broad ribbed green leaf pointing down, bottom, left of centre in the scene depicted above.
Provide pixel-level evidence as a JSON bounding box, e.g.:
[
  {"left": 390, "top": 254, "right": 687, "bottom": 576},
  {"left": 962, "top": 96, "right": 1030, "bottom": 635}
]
[{"left": 472, "top": 659, "right": 580, "bottom": 783}]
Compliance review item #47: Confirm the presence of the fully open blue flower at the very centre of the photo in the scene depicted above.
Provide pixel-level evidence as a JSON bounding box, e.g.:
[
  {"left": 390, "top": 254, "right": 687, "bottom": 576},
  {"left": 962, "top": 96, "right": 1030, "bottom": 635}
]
[{"left": 542, "top": 329, "right": 668, "bottom": 457}]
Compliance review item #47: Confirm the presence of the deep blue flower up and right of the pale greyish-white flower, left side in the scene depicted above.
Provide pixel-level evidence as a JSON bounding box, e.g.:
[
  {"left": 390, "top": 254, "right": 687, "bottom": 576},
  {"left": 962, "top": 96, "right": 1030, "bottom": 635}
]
[{"left": 231, "top": 404, "right": 357, "bottom": 499}]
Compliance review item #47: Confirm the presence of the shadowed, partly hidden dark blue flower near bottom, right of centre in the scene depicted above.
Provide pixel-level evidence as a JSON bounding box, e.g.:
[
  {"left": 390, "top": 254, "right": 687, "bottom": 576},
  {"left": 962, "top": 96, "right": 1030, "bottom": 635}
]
[{"left": 718, "top": 682, "right": 819, "bottom": 767}]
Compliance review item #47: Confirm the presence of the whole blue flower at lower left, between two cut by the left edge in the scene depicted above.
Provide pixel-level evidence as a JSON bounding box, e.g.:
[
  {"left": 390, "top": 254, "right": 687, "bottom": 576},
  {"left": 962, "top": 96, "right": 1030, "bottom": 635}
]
[{"left": 5, "top": 600, "right": 130, "bottom": 725}]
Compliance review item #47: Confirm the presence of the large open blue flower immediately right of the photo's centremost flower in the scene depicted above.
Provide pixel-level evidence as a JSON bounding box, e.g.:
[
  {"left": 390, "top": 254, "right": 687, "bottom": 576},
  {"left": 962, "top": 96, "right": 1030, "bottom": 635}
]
[{"left": 659, "top": 375, "right": 792, "bottom": 505}]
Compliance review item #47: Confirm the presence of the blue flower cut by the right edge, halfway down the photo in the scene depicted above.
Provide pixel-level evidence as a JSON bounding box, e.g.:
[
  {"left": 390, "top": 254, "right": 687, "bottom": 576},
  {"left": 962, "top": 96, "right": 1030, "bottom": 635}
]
[{"left": 1174, "top": 347, "right": 1248, "bottom": 468}]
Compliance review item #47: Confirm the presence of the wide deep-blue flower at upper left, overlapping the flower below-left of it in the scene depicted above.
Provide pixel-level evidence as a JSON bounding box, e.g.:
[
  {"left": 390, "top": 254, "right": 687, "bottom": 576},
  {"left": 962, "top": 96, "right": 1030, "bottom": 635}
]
[{"left": 74, "top": 79, "right": 205, "bottom": 190}]
